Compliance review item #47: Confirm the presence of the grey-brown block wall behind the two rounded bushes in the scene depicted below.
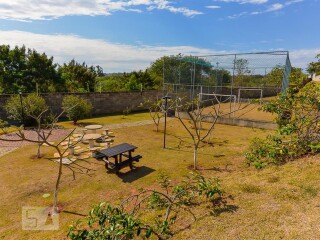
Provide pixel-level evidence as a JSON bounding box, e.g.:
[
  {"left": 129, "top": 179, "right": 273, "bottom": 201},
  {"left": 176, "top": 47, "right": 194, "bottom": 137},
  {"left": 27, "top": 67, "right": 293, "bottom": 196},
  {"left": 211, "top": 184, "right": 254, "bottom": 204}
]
[{"left": 0, "top": 90, "right": 163, "bottom": 119}]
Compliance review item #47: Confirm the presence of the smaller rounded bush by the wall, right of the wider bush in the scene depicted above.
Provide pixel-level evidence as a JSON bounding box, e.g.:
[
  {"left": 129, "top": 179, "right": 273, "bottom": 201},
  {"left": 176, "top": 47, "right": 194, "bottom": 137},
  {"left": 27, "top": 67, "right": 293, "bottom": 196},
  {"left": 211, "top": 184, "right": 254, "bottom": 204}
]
[{"left": 62, "top": 95, "right": 92, "bottom": 125}]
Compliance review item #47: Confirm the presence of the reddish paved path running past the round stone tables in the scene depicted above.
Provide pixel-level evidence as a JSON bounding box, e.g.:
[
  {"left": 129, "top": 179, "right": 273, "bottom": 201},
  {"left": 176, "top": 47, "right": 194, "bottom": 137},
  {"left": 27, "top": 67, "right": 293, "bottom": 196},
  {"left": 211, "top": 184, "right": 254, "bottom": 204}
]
[{"left": 0, "top": 118, "right": 172, "bottom": 157}]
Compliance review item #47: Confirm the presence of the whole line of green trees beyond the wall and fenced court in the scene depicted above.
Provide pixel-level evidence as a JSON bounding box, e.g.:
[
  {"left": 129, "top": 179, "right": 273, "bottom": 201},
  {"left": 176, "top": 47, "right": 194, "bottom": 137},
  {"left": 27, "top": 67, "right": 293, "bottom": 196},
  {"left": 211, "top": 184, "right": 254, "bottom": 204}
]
[{"left": 0, "top": 45, "right": 312, "bottom": 93}]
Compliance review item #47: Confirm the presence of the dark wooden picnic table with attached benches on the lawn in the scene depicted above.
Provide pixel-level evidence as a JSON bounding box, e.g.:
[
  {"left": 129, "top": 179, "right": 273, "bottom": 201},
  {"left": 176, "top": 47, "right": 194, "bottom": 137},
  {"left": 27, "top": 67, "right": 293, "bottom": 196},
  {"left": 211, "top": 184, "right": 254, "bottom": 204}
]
[{"left": 95, "top": 143, "right": 142, "bottom": 173}]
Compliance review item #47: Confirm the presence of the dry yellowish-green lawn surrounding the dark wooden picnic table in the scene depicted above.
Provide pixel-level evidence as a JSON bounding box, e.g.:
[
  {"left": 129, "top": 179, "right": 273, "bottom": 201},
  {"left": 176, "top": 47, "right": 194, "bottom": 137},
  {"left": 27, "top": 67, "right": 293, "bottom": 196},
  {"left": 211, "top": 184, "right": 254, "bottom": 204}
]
[{"left": 0, "top": 113, "right": 320, "bottom": 240}]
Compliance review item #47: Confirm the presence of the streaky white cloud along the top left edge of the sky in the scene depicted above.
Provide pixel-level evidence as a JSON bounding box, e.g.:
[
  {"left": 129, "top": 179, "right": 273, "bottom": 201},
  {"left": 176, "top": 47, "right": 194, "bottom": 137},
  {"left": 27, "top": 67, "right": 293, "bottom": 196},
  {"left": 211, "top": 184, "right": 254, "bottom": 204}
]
[{"left": 0, "top": 0, "right": 202, "bottom": 21}]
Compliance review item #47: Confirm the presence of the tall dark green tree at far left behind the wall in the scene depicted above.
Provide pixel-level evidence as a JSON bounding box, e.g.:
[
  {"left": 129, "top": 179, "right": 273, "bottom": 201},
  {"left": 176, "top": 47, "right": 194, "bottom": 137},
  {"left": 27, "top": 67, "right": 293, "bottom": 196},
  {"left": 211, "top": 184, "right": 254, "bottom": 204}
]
[{"left": 0, "top": 45, "right": 63, "bottom": 93}]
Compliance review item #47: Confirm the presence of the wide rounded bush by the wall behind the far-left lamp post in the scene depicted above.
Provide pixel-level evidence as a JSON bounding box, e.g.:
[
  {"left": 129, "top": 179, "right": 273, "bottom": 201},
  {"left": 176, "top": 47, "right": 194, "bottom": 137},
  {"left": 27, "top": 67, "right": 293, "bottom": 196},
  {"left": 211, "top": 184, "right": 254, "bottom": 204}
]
[{"left": 4, "top": 93, "right": 48, "bottom": 125}]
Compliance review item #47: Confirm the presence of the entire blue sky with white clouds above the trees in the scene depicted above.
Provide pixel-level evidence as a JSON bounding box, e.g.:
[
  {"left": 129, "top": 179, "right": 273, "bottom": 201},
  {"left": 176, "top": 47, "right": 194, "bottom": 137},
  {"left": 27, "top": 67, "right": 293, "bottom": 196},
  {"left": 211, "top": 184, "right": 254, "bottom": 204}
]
[{"left": 0, "top": 0, "right": 320, "bottom": 72}]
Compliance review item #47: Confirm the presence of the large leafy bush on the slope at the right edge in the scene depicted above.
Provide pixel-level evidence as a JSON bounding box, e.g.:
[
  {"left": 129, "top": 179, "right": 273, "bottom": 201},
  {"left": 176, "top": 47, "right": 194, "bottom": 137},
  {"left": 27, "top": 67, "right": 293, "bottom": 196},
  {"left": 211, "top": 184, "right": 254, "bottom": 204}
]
[{"left": 245, "top": 83, "right": 320, "bottom": 168}]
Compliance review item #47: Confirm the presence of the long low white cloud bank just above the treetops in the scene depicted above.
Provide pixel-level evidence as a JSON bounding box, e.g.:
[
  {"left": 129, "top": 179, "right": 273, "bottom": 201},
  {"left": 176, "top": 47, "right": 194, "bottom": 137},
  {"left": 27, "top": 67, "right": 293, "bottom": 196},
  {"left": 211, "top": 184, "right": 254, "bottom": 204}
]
[{"left": 0, "top": 31, "right": 320, "bottom": 72}]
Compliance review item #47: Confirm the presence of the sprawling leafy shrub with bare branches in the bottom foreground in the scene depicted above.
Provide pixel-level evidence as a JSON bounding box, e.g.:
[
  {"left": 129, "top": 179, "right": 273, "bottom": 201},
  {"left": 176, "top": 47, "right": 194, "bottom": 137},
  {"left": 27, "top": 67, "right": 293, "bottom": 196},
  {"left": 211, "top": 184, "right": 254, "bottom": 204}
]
[{"left": 68, "top": 173, "right": 225, "bottom": 240}]
